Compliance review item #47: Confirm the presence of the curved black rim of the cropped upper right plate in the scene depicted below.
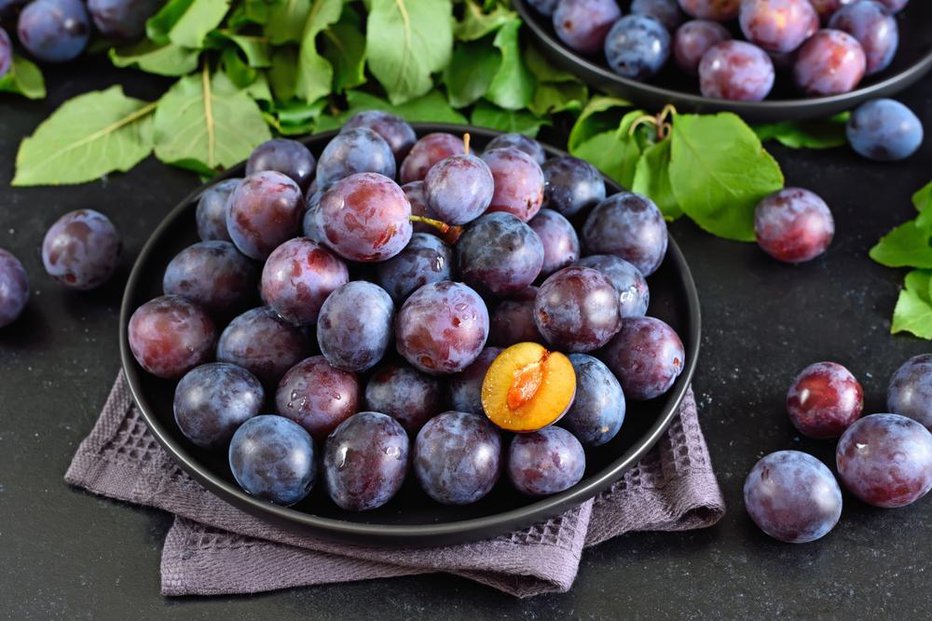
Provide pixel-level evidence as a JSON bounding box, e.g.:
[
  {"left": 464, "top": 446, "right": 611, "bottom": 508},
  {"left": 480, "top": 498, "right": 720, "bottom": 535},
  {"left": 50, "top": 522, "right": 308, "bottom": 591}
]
[{"left": 512, "top": 0, "right": 932, "bottom": 118}]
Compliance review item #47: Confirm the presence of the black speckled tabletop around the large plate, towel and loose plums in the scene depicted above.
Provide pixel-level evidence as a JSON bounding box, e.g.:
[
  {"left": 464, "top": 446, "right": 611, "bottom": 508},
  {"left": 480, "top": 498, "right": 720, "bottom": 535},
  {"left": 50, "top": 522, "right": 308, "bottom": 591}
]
[{"left": 0, "top": 59, "right": 932, "bottom": 619}]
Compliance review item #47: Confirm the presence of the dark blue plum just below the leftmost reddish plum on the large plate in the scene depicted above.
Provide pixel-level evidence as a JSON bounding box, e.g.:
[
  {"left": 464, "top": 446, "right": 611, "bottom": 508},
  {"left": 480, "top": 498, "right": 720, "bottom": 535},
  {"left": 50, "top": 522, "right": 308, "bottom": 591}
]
[{"left": 173, "top": 362, "right": 265, "bottom": 449}]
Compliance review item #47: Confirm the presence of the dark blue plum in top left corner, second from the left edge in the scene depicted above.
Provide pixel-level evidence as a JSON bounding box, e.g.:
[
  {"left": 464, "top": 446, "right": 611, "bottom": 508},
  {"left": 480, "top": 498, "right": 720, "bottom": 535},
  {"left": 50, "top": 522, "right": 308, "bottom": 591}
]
[{"left": 16, "top": 0, "right": 91, "bottom": 63}]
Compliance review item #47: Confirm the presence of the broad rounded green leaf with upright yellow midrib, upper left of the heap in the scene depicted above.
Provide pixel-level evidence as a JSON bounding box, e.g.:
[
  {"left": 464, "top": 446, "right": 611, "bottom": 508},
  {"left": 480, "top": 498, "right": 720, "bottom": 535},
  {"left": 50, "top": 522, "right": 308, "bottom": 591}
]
[{"left": 155, "top": 65, "right": 271, "bottom": 174}]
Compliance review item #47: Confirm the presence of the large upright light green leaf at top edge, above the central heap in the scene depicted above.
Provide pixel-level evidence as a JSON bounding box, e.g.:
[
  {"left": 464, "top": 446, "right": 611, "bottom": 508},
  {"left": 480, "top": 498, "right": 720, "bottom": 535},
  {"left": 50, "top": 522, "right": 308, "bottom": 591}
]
[{"left": 366, "top": 0, "right": 453, "bottom": 104}]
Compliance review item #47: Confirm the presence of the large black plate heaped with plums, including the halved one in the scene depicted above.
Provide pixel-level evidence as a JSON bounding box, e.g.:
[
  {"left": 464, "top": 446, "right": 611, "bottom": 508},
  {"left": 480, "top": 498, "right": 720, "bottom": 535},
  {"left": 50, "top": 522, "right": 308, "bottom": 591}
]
[{"left": 120, "top": 111, "right": 699, "bottom": 546}]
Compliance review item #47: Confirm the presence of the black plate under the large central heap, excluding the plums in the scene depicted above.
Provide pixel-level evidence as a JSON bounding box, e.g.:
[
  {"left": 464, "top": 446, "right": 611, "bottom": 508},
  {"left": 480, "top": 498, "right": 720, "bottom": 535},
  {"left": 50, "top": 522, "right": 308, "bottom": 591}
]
[{"left": 120, "top": 125, "right": 699, "bottom": 546}]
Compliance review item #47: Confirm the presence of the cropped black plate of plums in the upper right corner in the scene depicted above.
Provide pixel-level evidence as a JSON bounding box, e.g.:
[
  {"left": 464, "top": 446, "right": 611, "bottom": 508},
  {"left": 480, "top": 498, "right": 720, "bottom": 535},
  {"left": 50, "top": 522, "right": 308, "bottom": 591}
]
[{"left": 514, "top": 0, "right": 932, "bottom": 122}]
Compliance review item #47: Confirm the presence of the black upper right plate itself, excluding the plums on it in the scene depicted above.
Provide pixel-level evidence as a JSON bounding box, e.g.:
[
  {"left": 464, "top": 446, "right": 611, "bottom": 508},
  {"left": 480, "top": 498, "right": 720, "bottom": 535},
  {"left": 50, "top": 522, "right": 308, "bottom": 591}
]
[{"left": 512, "top": 0, "right": 932, "bottom": 123}]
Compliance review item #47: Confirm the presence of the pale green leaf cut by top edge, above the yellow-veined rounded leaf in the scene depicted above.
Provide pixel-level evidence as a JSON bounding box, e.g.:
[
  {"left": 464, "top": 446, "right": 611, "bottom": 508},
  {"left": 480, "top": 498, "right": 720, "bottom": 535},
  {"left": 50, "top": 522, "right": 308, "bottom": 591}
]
[{"left": 146, "top": 0, "right": 230, "bottom": 49}]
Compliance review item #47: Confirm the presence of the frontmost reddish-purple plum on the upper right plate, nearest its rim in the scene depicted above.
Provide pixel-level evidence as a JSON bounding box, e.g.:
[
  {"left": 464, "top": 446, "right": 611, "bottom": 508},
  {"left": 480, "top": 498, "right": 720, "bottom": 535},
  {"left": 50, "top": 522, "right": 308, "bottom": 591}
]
[{"left": 699, "top": 40, "right": 776, "bottom": 101}]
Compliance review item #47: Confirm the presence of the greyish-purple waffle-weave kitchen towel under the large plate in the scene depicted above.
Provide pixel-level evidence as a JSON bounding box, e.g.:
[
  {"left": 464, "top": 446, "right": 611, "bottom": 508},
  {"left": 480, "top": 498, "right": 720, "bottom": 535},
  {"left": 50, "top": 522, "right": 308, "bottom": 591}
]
[{"left": 65, "top": 372, "right": 725, "bottom": 597}]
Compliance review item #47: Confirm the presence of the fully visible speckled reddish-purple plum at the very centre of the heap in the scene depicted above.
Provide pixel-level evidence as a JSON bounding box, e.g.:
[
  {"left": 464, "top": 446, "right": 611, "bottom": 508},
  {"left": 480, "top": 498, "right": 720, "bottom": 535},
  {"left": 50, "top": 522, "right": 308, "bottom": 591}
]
[{"left": 395, "top": 280, "right": 489, "bottom": 375}]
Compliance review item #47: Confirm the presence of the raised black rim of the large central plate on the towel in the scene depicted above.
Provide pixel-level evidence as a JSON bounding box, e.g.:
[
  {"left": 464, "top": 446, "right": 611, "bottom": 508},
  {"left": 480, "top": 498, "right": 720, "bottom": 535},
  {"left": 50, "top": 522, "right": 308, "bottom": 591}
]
[{"left": 119, "top": 123, "right": 701, "bottom": 546}]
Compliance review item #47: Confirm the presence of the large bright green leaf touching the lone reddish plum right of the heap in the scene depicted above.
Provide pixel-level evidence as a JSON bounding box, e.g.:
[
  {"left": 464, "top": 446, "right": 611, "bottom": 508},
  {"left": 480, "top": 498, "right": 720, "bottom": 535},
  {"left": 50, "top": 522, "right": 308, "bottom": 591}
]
[{"left": 670, "top": 112, "right": 783, "bottom": 241}]
